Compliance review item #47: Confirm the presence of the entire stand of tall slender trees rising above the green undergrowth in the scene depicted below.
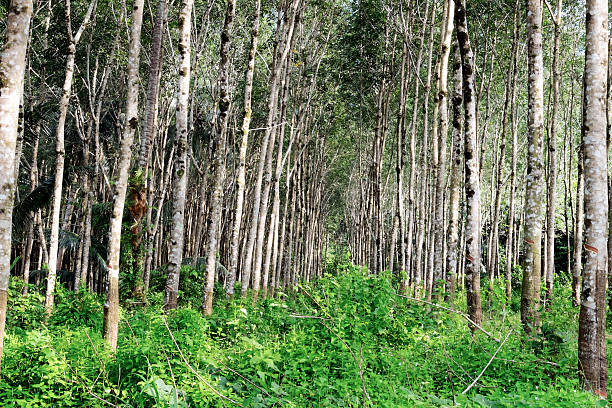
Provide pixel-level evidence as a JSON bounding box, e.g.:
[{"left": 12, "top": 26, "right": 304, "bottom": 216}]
[{"left": 0, "top": 0, "right": 612, "bottom": 393}]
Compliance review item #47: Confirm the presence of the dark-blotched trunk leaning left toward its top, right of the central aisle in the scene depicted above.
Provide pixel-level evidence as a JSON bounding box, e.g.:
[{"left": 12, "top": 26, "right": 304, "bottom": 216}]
[{"left": 455, "top": 0, "right": 482, "bottom": 329}]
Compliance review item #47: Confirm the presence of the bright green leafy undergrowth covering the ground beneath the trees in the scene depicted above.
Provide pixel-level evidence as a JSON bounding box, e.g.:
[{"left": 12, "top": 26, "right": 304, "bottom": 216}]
[{"left": 0, "top": 265, "right": 607, "bottom": 407}]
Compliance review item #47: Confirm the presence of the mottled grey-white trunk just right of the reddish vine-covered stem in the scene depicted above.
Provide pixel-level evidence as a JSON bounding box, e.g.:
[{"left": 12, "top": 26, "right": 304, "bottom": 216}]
[{"left": 162, "top": 0, "right": 193, "bottom": 310}]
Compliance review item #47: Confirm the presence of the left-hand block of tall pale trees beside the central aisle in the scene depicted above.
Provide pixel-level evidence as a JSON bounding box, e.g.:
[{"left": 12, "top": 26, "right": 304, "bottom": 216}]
[{"left": 3, "top": 0, "right": 333, "bottom": 356}]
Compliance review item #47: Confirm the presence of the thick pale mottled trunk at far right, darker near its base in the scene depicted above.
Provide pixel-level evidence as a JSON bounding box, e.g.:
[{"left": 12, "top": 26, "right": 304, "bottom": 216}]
[{"left": 578, "top": 0, "right": 608, "bottom": 398}]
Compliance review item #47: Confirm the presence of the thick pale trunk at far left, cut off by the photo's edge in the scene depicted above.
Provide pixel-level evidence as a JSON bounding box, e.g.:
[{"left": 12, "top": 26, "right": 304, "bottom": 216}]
[{"left": 0, "top": 0, "right": 33, "bottom": 361}]
